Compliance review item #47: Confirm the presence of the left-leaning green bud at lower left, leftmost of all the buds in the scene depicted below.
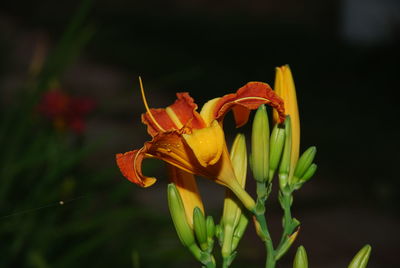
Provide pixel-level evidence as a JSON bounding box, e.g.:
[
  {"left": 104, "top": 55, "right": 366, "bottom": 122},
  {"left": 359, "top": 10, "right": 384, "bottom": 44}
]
[{"left": 168, "top": 183, "right": 200, "bottom": 249}]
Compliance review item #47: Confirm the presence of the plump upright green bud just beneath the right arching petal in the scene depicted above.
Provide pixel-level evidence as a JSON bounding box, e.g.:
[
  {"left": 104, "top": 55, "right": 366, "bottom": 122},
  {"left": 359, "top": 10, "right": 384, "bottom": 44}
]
[{"left": 250, "top": 105, "right": 269, "bottom": 182}]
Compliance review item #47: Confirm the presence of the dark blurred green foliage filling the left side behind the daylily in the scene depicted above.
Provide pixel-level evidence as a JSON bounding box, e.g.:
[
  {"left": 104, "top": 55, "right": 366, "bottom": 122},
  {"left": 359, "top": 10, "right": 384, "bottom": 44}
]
[{"left": 0, "top": 1, "right": 184, "bottom": 268}]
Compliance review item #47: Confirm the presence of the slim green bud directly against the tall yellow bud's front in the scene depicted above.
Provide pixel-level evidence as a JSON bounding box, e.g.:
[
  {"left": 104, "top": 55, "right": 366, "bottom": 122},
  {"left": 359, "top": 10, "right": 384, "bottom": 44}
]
[{"left": 279, "top": 116, "right": 292, "bottom": 190}]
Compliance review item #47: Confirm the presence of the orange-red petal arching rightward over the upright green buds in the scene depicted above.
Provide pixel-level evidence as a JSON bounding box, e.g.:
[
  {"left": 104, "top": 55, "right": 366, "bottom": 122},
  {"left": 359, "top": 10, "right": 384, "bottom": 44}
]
[{"left": 214, "top": 82, "right": 285, "bottom": 127}]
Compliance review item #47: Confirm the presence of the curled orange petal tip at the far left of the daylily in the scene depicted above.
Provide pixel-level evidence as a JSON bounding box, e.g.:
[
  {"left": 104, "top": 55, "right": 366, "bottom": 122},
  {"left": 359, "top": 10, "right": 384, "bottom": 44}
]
[{"left": 116, "top": 148, "right": 156, "bottom": 187}]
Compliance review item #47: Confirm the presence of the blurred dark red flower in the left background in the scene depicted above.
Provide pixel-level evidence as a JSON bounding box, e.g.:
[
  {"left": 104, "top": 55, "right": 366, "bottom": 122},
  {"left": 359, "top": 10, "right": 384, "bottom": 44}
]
[{"left": 38, "top": 89, "right": 95, "bottom": 133}]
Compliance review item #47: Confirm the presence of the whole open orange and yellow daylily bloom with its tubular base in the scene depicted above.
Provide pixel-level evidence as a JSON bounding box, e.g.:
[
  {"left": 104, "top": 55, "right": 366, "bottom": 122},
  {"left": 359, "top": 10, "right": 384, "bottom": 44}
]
[{"left": 116, "top": 80, "right": 285, "bottom": 208}]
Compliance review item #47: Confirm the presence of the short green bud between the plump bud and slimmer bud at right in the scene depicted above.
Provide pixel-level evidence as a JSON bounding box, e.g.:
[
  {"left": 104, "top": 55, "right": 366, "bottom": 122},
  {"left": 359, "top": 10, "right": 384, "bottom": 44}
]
[{"left": 269, "top": 124, "right": 285, "bottom": 181}]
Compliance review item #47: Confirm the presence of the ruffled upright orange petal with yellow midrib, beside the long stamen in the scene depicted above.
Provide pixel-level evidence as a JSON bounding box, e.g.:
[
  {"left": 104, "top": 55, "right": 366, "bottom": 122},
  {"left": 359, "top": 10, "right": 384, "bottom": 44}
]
[{"left": 142, "top": 92, "right": 205, "bottom": 137}]
